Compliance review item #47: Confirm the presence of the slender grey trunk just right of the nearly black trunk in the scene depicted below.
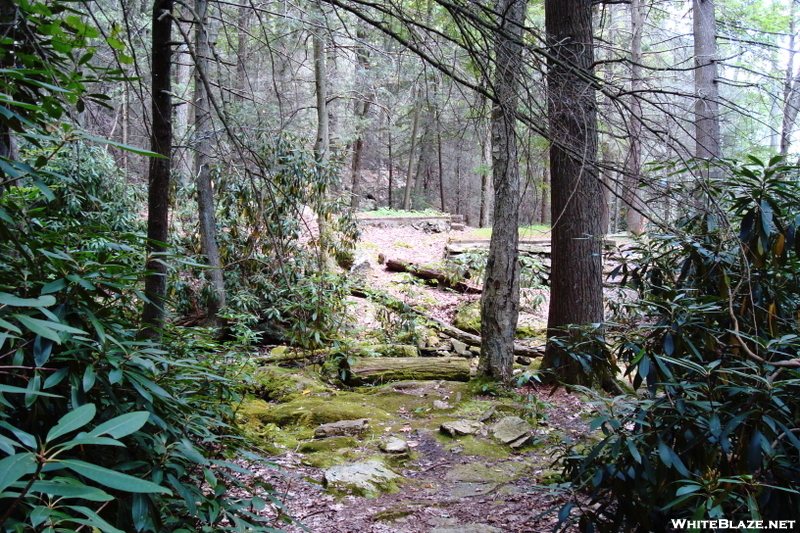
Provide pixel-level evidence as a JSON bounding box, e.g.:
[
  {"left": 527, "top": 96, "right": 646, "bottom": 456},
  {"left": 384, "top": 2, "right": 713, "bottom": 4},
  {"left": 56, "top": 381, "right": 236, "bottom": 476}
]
[{"left": 194, "top": 0, "right": 225, "bottom": 327}]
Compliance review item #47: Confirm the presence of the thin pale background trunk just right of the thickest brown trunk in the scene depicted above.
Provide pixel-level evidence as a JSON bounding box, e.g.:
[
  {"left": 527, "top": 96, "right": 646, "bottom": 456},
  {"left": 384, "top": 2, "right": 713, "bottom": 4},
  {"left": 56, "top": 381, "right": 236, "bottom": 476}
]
[{"left": 615, "top": 0, "right": 644, "bottom": 233}]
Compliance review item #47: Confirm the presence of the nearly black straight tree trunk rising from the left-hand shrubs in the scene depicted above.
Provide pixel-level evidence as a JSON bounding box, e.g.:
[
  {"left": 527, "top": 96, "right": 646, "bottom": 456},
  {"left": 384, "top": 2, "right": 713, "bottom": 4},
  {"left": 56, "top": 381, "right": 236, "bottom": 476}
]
[{"left": 140, "top": 0, "right": 173, "bottom": 339}]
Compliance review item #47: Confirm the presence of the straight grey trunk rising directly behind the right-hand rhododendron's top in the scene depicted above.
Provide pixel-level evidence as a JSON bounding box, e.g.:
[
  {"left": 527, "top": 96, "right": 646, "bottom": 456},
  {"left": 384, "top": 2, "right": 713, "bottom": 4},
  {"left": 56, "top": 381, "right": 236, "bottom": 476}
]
[{"left": 693, "top": 0, "right": 722, "bottom": 164}]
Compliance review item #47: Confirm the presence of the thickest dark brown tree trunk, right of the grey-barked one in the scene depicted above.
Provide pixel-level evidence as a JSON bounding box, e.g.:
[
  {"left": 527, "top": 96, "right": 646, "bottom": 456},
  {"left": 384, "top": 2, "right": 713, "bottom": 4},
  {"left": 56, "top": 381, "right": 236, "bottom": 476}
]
[{"left": 542, "top": 0, "right": 603, "bottom": 383}]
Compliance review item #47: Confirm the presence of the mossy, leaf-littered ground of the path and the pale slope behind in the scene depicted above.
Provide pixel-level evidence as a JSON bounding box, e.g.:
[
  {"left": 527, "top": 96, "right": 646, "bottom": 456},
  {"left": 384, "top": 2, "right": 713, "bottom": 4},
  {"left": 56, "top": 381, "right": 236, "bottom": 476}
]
[{"left": 241, "top": 222, "right": 592, "bottom": 533}]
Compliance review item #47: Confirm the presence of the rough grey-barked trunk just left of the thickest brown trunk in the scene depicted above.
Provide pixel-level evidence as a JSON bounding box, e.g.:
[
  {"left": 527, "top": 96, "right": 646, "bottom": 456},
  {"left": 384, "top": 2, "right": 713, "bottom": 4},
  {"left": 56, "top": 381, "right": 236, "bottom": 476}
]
[{"left": 478, "top": 0, "right": 528, "bottom": 383}]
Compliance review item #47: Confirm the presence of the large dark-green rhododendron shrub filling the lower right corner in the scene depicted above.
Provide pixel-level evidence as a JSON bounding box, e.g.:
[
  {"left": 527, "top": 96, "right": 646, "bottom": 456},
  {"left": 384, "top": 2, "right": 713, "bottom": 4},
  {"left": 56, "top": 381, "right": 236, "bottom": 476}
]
[{"left": 565, "top": 158, "right": 800, "bottom": 532}]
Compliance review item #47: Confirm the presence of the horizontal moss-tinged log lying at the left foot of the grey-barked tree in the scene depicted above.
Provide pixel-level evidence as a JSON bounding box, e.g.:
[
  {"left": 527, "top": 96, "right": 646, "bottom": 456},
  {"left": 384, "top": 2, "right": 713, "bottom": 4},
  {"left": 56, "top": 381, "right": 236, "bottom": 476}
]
[{"left": 347, "top": 357, "right": 469, "bottom": 385}]
